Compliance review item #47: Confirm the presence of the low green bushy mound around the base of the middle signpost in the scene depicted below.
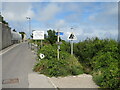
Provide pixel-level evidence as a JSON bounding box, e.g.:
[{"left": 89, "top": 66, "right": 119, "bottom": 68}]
[{"left": 34, "top": 45, "right": 83, "bottom": 77}]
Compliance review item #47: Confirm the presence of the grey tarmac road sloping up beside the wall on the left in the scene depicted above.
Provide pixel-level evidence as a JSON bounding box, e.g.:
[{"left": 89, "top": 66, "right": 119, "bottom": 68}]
[{"left": 2, "top": 43, "right": 35, "bottom": 88}]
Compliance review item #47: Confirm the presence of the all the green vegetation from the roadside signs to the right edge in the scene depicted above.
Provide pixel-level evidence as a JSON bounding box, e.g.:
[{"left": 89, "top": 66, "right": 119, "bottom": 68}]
[{"left": 31, "top": 31, "right": 120, "bottom": 89}]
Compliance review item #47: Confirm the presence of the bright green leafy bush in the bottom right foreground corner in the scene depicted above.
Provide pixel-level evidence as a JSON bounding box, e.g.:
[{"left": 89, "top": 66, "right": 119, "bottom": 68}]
[{"left": 92, "top": 49, "right": 120, "bottom": 88}]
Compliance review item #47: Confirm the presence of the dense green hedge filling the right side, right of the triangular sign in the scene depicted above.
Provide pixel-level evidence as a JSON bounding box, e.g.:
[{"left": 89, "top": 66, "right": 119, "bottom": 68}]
[{"left": 74, "top": 38, "right": 120, "bottom": 88}]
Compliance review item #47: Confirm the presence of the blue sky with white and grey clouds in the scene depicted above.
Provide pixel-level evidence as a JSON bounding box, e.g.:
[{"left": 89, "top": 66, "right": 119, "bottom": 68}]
[{"left": 0, "top": 0, "right": 118, "bottom": 41}]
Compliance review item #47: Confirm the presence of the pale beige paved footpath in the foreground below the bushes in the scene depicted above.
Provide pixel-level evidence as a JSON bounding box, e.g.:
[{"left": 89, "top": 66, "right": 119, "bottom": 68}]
[{"left": 28, "top": 73, "right": 99, "bottom": 89}]
